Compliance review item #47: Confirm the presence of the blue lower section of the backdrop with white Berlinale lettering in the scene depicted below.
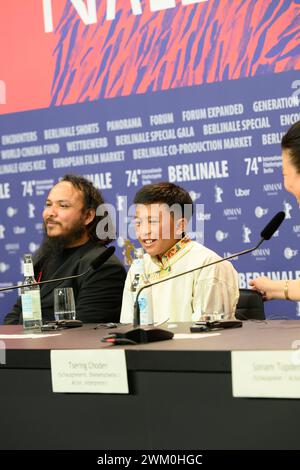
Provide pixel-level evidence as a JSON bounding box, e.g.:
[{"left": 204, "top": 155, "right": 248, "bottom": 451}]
[{"left": 0, "top": 72, "right": 300, "bottom": 319}]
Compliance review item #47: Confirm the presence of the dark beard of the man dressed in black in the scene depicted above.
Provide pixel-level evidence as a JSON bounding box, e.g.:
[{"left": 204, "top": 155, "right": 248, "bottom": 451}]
[{"left": 37, "top": 222, "right": 86, "bottom": 261}]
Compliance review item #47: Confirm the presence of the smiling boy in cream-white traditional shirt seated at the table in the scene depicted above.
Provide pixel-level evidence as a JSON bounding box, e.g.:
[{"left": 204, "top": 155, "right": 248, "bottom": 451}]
[{"left": 121, "top": 182, "right": 239, "bottom": 323}]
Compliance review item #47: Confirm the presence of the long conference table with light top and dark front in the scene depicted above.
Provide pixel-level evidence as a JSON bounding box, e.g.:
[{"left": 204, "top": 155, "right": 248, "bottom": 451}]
[{"left": 0, "top": 320, "right": 300, "bottom": 450}]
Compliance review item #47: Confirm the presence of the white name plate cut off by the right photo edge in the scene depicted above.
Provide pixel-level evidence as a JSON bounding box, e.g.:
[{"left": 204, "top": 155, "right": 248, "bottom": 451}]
[{"left": 231, "top": 350, "right": 300, "bottom": 398}]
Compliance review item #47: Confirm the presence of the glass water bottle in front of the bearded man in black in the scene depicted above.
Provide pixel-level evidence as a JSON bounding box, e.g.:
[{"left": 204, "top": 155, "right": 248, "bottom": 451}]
[{"left": 21, "top": 254, "right": 42, "bottom": 329}]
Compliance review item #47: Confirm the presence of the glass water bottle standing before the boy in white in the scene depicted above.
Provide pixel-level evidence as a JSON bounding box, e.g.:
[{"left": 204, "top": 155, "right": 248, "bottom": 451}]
[{"left": 131, "top": 248, "right": 153, "bottom": 325}]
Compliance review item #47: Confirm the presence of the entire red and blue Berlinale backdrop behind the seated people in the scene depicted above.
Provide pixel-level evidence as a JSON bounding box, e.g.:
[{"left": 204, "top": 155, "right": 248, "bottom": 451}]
[{"left": 0, "top": 0, "right": 300, "bottom": 321}]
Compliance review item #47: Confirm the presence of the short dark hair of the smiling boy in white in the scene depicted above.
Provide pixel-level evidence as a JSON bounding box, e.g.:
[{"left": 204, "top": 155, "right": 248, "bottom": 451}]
[{"left": 133, "top": 182, "right": 193, "bottom": 218}]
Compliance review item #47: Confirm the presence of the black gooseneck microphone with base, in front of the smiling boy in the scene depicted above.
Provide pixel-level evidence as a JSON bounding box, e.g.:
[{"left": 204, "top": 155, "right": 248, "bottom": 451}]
[{"left": 113, "top": 211, "right": 285, "bottom": 343}]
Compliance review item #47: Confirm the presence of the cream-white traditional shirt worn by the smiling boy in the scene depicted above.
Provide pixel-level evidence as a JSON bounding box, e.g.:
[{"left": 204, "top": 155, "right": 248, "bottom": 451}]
[{"left": 120, "top": 237, "right": 239, "bottom": 323}]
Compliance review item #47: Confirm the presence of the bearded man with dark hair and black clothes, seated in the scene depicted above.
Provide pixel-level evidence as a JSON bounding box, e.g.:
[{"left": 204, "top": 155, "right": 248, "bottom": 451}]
[{"left": 4, "top": 175, "right": 126, "bottom": 325}]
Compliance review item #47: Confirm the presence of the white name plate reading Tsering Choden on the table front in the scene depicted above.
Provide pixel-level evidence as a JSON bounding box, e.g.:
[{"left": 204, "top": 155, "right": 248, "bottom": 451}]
[{"left": 50, "top": 349, "right": 128, "bottom": 393}]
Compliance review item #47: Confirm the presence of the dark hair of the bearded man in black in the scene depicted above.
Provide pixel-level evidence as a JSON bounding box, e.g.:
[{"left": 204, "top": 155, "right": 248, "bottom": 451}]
[{"left": 60, "top": 174, "right": 112, "bottom": 245}]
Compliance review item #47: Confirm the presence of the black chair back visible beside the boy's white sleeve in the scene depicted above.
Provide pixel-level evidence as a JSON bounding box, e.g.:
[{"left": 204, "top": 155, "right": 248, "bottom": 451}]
[{"left": 235, "top": 289, "right": 266, "bottom": 320}]
